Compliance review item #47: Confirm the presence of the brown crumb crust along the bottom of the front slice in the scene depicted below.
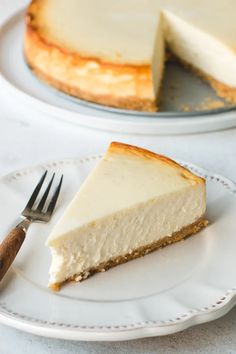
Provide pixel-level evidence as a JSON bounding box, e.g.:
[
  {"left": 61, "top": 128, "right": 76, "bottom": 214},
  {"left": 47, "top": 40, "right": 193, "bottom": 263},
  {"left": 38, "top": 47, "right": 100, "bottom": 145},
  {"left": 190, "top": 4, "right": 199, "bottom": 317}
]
[{"left": 49, "top": 218, "right": 208, "bottom": 291}]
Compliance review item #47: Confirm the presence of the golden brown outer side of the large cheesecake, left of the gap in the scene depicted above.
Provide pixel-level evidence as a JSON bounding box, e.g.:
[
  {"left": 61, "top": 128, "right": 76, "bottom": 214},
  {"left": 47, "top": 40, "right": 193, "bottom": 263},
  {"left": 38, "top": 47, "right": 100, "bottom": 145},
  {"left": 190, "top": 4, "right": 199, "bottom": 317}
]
[{"left": 24, "top": 0, "right": 157, "bottom": 112}]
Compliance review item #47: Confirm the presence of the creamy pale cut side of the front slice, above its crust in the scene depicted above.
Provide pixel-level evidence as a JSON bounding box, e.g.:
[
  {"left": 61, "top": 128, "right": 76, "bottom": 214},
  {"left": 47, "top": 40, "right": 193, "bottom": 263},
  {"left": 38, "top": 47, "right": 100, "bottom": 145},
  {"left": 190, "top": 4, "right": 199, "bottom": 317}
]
[{"left": 49, "top": 184, "right": 205, "bottom": 284}]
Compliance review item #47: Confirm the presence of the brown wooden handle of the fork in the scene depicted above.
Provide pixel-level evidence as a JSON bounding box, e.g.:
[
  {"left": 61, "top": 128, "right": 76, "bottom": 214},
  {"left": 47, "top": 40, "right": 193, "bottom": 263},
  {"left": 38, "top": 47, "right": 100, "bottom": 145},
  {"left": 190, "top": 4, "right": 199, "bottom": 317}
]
[{"left": 0, "top": 227, "right": 25, "bottom": 281}]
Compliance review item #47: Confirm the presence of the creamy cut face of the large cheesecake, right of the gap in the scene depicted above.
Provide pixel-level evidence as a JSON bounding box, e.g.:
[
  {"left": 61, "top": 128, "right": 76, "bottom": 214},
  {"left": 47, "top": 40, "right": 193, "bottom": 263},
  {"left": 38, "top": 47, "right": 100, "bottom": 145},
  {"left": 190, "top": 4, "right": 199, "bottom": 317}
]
[{"left": 164, "top": 11, "right": 236, "bottom": 87}]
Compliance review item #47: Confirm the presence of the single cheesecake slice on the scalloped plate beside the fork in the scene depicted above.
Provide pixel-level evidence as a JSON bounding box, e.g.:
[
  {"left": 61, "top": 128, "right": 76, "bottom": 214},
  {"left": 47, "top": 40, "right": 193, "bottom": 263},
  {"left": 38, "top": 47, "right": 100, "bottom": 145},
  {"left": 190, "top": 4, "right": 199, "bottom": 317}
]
[{"left": 47, "top": 142, "right": 207, "bottom": 290}]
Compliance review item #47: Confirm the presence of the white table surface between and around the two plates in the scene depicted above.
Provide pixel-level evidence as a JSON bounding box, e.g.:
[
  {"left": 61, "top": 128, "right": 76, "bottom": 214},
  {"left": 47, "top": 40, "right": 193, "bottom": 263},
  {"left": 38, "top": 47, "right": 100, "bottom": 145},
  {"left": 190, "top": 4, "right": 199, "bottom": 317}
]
[{"left": 0, "top": 0, "right": 236, "bottom": 354}]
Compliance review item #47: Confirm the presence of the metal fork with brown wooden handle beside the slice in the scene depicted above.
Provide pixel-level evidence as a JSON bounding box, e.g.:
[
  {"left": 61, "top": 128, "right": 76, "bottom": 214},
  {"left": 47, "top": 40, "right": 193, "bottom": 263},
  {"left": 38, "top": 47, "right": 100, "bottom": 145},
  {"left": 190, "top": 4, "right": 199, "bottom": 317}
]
[{"left": 0, "top": 171, "right": 63, "bottom": 281}]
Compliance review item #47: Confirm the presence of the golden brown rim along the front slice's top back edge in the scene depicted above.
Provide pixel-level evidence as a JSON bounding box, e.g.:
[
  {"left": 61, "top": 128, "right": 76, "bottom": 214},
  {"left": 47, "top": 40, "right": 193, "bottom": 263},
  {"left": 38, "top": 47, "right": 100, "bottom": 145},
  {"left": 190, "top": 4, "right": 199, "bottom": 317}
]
[{"left": 105, "top": 141, "right": 205, "bottom": 183}]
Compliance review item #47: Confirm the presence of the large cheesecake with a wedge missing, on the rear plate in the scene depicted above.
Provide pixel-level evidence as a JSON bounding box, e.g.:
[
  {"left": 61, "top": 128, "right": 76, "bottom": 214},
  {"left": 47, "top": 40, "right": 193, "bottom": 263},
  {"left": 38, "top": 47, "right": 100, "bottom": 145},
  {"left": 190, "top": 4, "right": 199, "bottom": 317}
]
[{"left": 24, "top": 0, "right": 236, "bottom": 111}]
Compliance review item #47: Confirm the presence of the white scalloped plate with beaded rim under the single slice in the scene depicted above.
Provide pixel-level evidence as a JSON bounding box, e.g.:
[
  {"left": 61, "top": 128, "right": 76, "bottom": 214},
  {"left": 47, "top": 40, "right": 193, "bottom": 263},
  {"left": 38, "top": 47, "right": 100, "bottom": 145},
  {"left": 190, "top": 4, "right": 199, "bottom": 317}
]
[{"left": 0, "top": 156, "right": 236, "bottom": 341}]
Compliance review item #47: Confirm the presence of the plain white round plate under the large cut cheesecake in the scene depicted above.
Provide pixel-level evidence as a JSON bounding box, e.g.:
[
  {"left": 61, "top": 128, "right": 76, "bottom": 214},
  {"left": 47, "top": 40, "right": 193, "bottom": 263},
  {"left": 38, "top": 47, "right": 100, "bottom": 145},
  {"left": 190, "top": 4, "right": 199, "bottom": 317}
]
[{"left": 0, "top": 3, "right": 236, "bottom": 134}]
